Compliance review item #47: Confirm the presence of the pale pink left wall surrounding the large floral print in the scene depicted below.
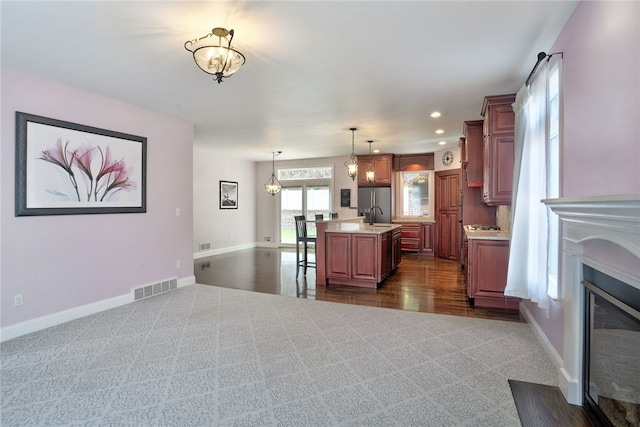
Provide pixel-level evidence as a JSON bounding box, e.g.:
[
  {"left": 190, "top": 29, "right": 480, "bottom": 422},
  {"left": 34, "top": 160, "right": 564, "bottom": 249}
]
[{"left": 0, "top": 69, "right": 193, "bottom": 327}]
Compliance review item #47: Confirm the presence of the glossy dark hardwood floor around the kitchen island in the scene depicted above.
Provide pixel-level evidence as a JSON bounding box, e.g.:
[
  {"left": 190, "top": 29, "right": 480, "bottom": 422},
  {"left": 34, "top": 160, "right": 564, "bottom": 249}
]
[{"left": 194, "top": 248, "right": 523, "bottom": 322}]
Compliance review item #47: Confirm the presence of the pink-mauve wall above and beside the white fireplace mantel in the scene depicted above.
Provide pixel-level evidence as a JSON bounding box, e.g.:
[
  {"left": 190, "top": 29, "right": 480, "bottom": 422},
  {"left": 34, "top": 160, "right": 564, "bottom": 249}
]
[{"left": 528, "top": 1, "right": 640, "bottom": 355}]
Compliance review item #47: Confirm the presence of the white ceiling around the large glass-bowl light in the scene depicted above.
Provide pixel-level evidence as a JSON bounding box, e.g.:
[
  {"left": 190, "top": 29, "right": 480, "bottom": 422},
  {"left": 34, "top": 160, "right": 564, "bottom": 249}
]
[{"left": 1, "top": 0, "right": 577, "bottom": 161}]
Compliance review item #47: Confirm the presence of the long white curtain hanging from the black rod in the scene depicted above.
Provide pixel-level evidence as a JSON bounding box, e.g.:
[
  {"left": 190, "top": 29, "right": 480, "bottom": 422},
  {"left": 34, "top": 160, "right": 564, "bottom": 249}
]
[{"left": 504, "top": 61, "right": 549, "bottom": 309}]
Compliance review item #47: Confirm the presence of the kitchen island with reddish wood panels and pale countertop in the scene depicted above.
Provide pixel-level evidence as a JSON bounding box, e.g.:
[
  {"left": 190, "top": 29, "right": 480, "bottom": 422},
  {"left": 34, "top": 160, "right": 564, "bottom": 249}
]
[{"left": 316, "top": 219, "right": 402, "bottom": 288}]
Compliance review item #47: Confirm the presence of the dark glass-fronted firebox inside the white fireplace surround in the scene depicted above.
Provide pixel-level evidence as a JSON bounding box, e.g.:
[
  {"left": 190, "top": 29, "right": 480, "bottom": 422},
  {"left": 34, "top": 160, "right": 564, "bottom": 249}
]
[{"left": 583, "top": 271, "right": 640, "bottom": 426}]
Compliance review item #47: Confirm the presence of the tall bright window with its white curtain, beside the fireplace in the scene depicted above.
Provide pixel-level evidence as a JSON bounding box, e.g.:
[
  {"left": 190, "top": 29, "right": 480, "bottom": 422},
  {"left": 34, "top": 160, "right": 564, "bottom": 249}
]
[{"left": 505, "top": 54, "right": 562, "bottom": 309}]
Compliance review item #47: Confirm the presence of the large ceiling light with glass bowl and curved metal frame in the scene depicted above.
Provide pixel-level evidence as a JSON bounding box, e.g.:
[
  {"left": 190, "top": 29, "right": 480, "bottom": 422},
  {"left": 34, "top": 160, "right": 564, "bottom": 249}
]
[{"left": 184, "top": 28, "right": 245, "bottom": 83}]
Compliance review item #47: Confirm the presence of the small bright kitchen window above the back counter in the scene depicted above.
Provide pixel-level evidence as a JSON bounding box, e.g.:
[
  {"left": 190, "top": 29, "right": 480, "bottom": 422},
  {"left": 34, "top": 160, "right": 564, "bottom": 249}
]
[{"left": 395, "top": 170, "right": 433, "bottom": 217}]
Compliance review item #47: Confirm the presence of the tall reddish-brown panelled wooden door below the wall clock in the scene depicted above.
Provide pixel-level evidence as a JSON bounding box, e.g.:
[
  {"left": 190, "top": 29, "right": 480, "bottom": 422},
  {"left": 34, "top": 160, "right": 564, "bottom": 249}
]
[{"left": 435, "top": 169, "right": 462, "bottom": 261}]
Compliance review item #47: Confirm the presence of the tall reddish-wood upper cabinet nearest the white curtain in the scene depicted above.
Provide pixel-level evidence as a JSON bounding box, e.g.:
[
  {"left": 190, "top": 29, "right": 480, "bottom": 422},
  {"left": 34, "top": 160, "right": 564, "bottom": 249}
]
[{"left": 482, "top": 94, "right": 515, "bottom": 206}]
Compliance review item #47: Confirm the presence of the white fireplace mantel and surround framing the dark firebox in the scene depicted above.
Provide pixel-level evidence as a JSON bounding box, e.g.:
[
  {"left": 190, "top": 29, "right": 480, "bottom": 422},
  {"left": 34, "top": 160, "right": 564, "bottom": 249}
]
[{"left": 543, "top": 193, "right": 640, "bottom": 405}]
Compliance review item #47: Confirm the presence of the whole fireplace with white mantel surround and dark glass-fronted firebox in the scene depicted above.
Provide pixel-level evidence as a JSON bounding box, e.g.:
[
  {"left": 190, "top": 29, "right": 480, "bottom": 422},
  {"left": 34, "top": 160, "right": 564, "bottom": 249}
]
[{"left": 543, "top": 194, "right": 640, "bottom": 420}]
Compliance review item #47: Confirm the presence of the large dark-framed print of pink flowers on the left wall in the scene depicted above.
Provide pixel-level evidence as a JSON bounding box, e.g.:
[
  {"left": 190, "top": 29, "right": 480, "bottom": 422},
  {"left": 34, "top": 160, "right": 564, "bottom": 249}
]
[{"left": 15, "top": 112, "right": 147, "bottom": 216}]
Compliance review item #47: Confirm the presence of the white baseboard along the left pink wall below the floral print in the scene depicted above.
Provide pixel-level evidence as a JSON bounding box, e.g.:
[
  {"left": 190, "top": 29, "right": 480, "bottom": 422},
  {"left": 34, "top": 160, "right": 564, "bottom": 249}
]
[{"left": 0, "top": 276, "right": 196, "bottom": 342}]
